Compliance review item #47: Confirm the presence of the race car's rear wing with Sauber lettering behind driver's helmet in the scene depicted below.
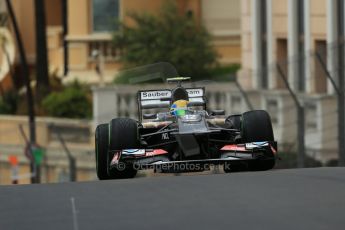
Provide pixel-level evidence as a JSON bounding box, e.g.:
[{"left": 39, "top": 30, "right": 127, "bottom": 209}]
[{"left": 137, "top": 87, "right": 206, "bottom": 120}]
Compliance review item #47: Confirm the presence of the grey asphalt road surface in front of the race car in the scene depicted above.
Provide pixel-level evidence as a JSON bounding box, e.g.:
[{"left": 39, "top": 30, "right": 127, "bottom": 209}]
[{"left": 0, "top": 168, "right": 345, "bottom": 230}]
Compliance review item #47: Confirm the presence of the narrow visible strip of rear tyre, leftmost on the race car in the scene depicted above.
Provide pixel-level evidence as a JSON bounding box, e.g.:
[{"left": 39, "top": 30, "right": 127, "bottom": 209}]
[{"left": 95, "top": 124, "right": 111, "bottom": 180}]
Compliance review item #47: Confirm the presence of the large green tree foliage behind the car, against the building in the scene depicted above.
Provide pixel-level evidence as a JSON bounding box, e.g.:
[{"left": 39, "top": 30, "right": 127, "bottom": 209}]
[{"left": 114, "top": 2, "right": 216, "bottom": 79}]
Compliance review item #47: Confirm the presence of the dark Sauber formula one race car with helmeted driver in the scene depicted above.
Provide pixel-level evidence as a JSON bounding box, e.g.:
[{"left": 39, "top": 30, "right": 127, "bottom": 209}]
[{"left": 95, "top": 63, "right": 277, "bottom": 180}]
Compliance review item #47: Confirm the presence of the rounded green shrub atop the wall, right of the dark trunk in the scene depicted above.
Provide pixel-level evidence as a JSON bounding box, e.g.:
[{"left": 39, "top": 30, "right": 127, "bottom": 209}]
[{"left": 42, "top": 82, "right": 92, "bottom": 118}]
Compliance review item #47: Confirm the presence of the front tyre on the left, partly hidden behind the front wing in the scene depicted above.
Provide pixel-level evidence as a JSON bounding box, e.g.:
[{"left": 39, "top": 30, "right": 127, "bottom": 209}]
[{"left": 109, "top": 118, "right": 140, "bottom": 179}]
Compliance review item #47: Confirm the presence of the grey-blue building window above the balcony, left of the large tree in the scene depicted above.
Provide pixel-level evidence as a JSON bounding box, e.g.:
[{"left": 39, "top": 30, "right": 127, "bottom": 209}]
[{"left": 92, "top": 0, "right": 120, "bottom": 32}]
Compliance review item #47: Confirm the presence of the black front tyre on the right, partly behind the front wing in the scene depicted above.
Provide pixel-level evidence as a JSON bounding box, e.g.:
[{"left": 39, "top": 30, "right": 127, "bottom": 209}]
[{"left": 241, "top": 110, "right": 275, "bottom": 171}]
